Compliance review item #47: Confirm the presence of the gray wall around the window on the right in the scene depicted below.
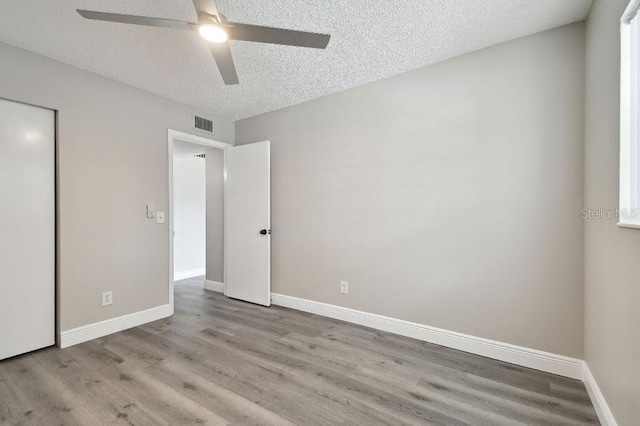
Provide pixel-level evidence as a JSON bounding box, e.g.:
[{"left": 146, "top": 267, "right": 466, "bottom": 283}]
[{"left": 584, "top": 0, "right": 640, "bottom": 425}]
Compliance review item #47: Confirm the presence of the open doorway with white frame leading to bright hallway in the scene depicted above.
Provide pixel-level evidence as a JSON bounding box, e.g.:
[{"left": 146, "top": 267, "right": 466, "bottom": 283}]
[{"left": 169, "top": 130, "right": 232, "bottom": 307}]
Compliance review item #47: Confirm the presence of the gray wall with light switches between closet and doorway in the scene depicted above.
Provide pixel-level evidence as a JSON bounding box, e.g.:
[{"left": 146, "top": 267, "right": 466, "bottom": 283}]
[{"left": 0, "top": 40, "right": 234, "bottom": 331}]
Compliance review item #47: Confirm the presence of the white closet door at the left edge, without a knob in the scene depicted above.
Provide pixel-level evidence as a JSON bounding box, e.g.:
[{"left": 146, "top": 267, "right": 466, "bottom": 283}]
[{"left": 0, "top": 99, "right": 55, "bottom": 359}]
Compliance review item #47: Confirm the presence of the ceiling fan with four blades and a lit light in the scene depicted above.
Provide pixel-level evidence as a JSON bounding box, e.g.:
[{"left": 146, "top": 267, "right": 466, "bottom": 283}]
[{"left": 77, "top": 0, "right": 331, "bottom": 85}]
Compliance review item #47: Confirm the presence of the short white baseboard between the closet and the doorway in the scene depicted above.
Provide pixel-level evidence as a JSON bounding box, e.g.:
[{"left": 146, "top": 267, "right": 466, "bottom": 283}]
[{"left": 60, "top": 305, "right": 173, "bottom": 348}]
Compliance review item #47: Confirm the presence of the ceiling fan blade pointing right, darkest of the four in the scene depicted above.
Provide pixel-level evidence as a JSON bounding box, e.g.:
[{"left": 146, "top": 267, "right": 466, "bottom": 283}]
[{"left": 227, "top": 22, "right": 331, "bottom": 49}]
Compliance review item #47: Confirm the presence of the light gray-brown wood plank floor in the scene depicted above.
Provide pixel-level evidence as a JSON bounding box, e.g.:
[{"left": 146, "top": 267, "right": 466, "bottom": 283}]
[{"left": 0, "top": 279, "right": 598, "bottom": 426}]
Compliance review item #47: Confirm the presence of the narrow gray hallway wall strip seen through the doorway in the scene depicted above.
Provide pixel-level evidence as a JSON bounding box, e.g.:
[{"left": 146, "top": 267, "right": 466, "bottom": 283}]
[{"left": 205, "top": 148, "right": 224, "bottom": 283}]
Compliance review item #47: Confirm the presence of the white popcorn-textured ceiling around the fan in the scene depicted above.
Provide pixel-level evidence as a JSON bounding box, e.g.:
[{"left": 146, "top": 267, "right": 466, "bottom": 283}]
[{"left": 0, "top": 0, "right": 591, "bottom": 119}]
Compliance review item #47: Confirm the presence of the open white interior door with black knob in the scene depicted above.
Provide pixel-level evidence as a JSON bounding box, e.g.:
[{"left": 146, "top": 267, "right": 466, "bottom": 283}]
[{"left": 224, "top": 141, "right": 271, "bottom": 306}]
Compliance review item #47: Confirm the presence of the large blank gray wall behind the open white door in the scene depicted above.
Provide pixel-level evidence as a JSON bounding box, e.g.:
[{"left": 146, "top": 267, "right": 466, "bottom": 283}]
[{"left": 236, "top": 23, "right": 584, "bottom": 358}]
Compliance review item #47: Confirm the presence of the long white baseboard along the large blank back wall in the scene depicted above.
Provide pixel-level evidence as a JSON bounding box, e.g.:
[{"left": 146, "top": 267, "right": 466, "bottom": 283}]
[{"left": 271, "top": 293, "right": 583, "bottom": 380}]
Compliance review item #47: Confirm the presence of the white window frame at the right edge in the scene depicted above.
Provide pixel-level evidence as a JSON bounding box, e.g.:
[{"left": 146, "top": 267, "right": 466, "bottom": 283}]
[{"left": 618, "top": 0, "right": 640, "bottom": 229}]
